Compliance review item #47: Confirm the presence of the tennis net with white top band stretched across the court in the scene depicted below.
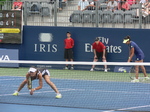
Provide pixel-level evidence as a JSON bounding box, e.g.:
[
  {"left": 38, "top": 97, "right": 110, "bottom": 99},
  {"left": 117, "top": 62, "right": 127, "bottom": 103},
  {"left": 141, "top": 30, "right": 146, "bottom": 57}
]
[{"left": 0, "top": 61, "right": 150, "bottom": 111}]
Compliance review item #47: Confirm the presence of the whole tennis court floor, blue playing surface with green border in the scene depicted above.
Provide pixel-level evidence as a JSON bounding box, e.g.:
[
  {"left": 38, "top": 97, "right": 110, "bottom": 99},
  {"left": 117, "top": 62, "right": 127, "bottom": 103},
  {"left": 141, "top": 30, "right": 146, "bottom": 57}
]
[{"left": 0, "top": 68, "right": 150, "bottom": 112}]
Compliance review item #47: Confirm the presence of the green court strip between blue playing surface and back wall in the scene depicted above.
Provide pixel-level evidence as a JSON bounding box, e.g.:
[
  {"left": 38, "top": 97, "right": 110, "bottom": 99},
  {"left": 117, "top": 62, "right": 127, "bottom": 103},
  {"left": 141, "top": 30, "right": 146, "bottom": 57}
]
[{"left": 0, "top": 68, "right": 147, "bottom": 83}]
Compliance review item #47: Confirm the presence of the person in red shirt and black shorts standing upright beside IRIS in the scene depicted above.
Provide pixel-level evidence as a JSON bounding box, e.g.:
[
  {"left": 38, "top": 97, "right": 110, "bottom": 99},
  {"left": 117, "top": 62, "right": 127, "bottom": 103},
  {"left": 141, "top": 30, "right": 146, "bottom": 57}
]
[{"left": 64, "top": 32, "right": 74, "bottom": 70}]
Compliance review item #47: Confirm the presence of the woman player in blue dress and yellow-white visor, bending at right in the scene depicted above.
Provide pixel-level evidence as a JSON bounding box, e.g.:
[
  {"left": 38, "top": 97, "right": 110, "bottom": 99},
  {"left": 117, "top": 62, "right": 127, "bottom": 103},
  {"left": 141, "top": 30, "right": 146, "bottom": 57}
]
[{"left": 123, "top": 36, "right": 149, "bottom": 82}]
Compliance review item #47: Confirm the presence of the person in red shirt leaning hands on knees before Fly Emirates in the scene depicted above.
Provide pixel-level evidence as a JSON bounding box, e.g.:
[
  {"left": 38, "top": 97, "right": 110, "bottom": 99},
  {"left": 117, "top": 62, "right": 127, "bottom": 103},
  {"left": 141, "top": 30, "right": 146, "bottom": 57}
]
[{"left": 90, "top": 37, "right": 107, "bottom": 72}]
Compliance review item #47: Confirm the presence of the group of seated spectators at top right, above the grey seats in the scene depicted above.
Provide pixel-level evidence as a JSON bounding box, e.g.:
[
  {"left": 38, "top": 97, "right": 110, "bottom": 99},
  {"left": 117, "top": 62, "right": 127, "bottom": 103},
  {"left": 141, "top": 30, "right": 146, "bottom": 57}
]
[{"left": 78, "top": 0, "right": 150, "bottom": 17}]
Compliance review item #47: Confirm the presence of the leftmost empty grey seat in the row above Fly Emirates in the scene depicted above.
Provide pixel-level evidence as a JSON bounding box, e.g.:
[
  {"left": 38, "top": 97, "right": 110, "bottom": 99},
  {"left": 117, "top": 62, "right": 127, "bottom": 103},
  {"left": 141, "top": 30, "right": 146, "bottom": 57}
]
[{"left": 70, "top": 10, "right": 82, "bottom": 23}]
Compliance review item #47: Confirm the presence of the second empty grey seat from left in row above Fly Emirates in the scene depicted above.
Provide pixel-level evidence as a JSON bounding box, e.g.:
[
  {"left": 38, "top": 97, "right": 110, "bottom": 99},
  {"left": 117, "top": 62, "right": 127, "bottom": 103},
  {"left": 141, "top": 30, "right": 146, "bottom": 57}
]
[{"left": 82, "top": 10, "right": 92, "bottom": 23}]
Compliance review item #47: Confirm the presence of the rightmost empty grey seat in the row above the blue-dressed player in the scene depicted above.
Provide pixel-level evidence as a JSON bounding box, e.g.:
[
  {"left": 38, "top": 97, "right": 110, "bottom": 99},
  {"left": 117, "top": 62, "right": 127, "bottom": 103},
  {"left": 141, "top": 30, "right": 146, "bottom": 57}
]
[{"left": 124, "top": 10, "right": 135, "bottom": 23}]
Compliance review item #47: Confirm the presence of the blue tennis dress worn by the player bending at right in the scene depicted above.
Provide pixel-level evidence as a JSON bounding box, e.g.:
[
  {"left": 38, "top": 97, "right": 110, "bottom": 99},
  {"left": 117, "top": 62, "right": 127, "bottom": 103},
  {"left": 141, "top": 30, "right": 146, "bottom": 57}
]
[{"left": 129, "top": 41, "right": 145, "bottom": 61}]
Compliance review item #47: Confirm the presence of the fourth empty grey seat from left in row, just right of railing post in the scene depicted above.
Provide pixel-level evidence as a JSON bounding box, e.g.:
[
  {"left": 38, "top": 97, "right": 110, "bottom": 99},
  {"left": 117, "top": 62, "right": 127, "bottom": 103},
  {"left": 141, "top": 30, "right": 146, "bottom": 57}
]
[{"left": 102, "top": 10, "right": 113, "bottom": 23}]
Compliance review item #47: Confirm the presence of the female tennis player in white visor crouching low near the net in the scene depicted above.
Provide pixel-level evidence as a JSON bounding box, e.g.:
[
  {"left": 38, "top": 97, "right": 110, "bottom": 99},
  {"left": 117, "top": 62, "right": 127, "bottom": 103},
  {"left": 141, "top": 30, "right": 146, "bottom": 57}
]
[{"left": 13, "top": 67, "right": 62, "bottom": 98}]
